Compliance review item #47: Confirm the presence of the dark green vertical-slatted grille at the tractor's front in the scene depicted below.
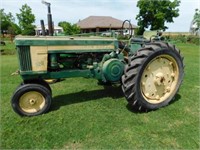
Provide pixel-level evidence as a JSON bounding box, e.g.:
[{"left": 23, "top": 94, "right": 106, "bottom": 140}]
[{"left": 17, "top": 46, "right": 32, "bottom": 71}]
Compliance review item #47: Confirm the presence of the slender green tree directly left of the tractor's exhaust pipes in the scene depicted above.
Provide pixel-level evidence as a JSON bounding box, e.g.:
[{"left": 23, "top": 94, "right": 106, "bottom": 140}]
[{"left": 16, "top": 4, "right": 35, "bottom": 35}]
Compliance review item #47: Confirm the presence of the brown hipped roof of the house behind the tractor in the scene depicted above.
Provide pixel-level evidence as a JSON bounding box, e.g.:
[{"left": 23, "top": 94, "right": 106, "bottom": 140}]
[{"left": 77, "top": 16, "right": 137, "bottom": 29}]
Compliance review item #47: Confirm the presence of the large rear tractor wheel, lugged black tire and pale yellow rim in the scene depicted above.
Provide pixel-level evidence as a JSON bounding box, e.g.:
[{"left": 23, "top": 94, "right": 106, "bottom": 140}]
[{"left": 122, "top": 42, "right": 184, "bottom": 111}]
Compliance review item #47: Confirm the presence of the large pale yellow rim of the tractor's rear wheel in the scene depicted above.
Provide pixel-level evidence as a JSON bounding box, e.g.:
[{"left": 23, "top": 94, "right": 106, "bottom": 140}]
[{"left": 140, "top": 55, "right": 179, "bottom": 104}]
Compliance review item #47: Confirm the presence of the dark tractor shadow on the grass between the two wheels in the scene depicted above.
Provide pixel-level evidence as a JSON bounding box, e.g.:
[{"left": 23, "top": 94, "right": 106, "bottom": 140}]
[{"left": 51, "top": 86, "right": 124, "bottom": 111}]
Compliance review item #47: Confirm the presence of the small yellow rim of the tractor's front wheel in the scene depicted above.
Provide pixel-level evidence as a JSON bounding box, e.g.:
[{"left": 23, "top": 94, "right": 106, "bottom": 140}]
[{"left": 19, "top": 91, "right": 45, "bottom": 113}]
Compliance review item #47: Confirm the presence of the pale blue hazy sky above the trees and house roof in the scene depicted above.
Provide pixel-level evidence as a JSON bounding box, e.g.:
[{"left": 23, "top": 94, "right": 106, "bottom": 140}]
[{"left": 0, "top": 0, "right": 200, "bottom": 32}]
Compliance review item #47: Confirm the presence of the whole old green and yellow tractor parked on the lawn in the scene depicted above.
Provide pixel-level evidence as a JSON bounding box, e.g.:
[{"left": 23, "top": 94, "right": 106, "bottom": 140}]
[{"left": 11, "top": 21, "right": 184, "bottom": 116}]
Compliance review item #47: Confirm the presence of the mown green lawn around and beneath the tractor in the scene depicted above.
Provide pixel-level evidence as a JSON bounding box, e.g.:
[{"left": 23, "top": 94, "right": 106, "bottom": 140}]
[{"left": 0, "top": 44, "right": 200, "bottom": 149}]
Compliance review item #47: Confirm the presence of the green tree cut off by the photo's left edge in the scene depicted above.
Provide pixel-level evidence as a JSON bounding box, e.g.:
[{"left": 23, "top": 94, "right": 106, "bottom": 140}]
[{"left": 0, "top": 9, "right": 21, "bottom": 35}]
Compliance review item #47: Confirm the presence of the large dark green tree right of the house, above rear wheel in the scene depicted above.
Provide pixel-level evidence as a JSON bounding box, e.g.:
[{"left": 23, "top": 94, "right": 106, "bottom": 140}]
[{"left": 136, "top": 0, "right": 180, "bottom": 34}]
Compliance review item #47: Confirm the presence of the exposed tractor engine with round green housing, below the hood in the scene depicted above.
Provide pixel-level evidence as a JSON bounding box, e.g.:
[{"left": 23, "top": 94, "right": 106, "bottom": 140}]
[{"left": 48, "top": 52, "right": 124, "bottom": 82}]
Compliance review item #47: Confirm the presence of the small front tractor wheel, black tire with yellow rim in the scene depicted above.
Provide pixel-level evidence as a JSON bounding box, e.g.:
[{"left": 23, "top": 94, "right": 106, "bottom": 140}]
[{"left": 11, "top": 84, "right": 52, "bottom": 116}]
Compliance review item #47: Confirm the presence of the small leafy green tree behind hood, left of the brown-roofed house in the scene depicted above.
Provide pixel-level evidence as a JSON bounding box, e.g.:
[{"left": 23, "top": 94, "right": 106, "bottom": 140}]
[{"left": 58, "top": 21, "right": 80, "bottom": 35}]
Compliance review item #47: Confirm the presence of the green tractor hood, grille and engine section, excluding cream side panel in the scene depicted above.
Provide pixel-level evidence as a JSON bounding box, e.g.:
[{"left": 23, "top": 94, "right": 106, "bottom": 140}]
[{"left": 15, "top": 37, "right": 124, "bottom": 82}]
